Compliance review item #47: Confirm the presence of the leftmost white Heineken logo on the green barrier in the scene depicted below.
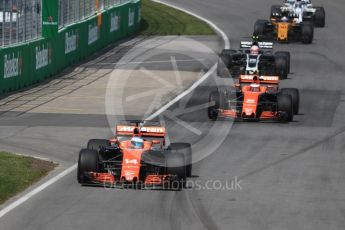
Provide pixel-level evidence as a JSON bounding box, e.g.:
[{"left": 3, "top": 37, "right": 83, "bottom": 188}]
[{"left": 4, "top": 52, "right": 22, "bottom": 79}]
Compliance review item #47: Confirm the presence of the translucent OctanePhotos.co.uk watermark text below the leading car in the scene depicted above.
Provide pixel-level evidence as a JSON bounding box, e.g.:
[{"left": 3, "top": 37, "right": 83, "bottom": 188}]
[{"left": 103, "top": 177, "right": 243, "bottom": 192}]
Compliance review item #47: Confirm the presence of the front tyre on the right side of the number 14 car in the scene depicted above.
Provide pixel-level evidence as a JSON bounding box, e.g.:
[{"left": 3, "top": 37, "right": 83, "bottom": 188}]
[{"left": 165, "top": 153, "right": 186, "bottom": 190}]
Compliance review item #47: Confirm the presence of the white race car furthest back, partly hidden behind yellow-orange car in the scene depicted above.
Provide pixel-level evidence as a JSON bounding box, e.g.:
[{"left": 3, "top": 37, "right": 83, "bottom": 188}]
[{"left": 271, "top": 0, "right": 326, "bottom": 27}]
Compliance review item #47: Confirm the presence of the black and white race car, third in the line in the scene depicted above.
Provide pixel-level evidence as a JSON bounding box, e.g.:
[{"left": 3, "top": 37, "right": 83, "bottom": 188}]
[{"left": 217, "top": 41, "right": 290, "bottom": 79}]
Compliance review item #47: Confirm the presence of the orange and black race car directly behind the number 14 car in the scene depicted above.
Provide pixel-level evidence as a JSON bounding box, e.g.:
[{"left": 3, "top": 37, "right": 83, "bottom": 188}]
[{"left": 208, "top": 75, "right": 299, "bottom": 122}]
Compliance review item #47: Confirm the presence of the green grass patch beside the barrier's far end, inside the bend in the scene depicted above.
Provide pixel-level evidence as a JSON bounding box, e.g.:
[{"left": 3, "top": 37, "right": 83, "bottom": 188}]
[{"left": 140, "top": 0, "right": 215, "bottom": 36}]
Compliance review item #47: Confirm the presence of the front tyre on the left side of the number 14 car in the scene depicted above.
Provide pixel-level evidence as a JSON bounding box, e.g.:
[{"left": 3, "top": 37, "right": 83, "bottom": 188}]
[{"left": 77, "top": 149, "right": 98, "bottom": 184}]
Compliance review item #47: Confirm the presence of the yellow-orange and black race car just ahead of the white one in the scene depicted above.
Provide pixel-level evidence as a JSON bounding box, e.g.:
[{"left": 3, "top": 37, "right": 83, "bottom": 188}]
[{"left": 254, "top": 7, "right": 314, "bottom": 44}]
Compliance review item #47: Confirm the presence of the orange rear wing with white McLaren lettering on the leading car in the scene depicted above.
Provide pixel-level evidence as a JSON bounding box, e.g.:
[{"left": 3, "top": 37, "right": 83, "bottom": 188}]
[{"left": 115, "top": 124, "right": 166, "bottom": 138}]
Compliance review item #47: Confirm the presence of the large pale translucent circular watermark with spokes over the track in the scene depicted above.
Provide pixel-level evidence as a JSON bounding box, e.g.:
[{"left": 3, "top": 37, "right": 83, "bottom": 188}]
[{"left": 105, "top": 36, "right": 233, "bottom": 168}]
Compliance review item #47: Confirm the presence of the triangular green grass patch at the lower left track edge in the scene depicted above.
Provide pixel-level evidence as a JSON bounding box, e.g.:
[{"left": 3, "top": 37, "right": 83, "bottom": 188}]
[{"left": 0, "top": 152, "right": 56, "bottom": 204}]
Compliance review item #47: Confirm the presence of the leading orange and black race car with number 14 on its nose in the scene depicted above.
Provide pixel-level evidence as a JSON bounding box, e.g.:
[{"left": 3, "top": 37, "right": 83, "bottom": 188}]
[{"left": 78, "top": 121, "right": 192, "bottom": 189}]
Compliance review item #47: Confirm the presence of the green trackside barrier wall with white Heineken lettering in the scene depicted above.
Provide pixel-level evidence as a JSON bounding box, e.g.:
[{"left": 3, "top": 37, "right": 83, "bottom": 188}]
[{"left": 0, "top": 0, "right": 141, "bottom": 94}]
